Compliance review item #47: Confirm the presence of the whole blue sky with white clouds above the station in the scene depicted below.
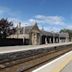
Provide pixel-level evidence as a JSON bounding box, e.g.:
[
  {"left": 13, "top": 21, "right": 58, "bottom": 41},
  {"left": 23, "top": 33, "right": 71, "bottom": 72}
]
[{"left": 0, "top": 0, "right": 72, "bottom": 32}]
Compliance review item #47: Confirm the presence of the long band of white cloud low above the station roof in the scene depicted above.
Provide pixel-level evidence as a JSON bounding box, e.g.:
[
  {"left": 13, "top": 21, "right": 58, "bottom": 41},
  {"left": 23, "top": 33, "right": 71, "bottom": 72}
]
[{"left": 8, "top": 15, "right": 72, "bottom": 32}]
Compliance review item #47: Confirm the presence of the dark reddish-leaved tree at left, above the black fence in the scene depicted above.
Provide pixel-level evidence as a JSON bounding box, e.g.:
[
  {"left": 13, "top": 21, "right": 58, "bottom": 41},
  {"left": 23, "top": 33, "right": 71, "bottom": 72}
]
[{"left": 0, "top": 18, "right": 13, "bottom": 38}]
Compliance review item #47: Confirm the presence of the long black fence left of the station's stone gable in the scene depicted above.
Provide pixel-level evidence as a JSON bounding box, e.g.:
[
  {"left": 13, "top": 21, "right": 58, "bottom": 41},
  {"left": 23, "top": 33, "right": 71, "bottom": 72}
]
[{"left": 0, "top": 38, "right": 29, "bottom": 46}]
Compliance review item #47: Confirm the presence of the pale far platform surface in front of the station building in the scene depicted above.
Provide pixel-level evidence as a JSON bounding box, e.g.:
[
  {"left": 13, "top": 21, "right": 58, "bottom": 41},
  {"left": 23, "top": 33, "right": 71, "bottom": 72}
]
[{"left": 0, "top": 42, "right": 72, "bottom": 54}]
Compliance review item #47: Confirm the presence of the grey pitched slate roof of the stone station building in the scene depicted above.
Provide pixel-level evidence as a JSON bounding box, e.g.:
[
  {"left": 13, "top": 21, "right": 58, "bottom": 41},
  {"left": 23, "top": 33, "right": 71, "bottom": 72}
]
[{"left": 21, "top": 23, "right": 69, "bottom": 37}]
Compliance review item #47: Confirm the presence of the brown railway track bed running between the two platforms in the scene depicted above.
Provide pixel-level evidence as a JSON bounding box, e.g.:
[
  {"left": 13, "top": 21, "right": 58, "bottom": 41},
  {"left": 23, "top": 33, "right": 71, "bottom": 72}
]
[{"left": 0, "top": 46, "right": 72, "bottom": 72}]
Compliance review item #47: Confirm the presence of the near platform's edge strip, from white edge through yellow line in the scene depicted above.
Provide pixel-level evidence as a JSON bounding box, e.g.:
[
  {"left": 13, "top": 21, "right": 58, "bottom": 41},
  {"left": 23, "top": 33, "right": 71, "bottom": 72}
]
[{"left": 32, "top": 51, "right": 72, "bottom": 72}]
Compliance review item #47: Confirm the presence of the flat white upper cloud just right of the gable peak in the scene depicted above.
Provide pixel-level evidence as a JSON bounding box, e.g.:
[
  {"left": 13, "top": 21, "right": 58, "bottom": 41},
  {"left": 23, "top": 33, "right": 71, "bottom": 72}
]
[{"left": 35, "top": 15, "right": 64, "bottom": 25}]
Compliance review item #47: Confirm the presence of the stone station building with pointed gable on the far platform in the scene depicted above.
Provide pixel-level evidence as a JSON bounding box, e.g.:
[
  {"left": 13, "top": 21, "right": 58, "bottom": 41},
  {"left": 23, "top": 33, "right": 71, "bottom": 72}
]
[{"left": 7, "top": 22, "right": 69, "bottom": 45}]
